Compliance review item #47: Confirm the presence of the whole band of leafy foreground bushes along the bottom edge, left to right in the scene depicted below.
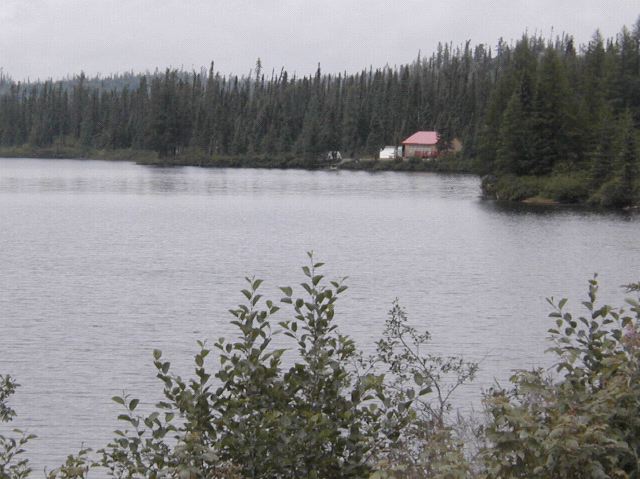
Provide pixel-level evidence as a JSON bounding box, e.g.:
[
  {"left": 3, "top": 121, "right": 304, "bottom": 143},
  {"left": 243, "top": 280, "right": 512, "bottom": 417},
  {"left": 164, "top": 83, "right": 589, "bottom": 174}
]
[{"left": 0, "top": 262, "right": 640, "bottom": 479}]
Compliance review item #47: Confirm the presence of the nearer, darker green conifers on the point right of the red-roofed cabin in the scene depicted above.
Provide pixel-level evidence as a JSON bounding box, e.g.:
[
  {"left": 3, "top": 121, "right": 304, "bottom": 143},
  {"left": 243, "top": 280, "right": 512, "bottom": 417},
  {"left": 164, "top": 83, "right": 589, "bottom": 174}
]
[{"left": 476, "top": 22, "right": 640, "bottom": 206}]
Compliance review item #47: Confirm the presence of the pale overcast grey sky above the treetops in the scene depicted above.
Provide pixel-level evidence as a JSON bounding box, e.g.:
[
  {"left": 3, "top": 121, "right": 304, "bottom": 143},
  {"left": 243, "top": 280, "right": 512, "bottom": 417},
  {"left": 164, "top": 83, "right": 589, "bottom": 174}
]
[{"left": 0, "top": 0, "right": 640, "bottom": 80}]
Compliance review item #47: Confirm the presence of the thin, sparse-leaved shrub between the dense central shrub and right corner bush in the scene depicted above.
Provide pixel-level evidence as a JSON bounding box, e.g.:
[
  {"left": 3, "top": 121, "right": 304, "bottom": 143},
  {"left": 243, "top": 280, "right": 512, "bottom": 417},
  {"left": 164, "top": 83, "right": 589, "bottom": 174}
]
[{"left": 371, "top": 300, "right": 478, "bottom": 479}]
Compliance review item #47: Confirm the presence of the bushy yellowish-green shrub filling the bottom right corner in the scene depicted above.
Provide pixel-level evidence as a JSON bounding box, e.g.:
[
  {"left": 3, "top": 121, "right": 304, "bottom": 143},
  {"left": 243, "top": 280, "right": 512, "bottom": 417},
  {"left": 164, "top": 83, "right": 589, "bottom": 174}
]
[{"left": 484, "top": 279, "right": 640, "bottom": 479}]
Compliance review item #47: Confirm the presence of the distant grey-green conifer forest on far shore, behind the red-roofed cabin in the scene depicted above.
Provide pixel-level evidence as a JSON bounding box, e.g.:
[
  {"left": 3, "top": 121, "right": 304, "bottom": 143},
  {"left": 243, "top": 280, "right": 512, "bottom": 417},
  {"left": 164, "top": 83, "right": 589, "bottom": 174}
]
[{"left": 0, "top": 49, "right": 490, "bottom": 158}]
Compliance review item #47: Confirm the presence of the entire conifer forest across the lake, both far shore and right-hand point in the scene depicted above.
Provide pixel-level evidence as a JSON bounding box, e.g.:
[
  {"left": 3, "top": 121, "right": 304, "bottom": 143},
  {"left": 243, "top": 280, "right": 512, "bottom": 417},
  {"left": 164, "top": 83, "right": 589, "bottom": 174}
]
[{"left": 0, "top": 21, "right": 640, "bottom": 205}]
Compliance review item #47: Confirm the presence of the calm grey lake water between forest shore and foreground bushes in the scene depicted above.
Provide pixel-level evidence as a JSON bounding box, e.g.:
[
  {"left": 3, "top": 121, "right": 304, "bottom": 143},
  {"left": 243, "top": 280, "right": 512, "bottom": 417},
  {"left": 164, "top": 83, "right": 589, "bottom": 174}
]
[{"left": 0, "top": 159, "right": 640, "bottom": 470}]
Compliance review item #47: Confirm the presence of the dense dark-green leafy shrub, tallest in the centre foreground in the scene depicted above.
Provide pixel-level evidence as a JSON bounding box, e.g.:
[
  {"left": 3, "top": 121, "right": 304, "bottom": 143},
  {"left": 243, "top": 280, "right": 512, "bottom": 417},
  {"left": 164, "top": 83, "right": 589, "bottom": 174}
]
[{"left": 94, "top": 258, "right": 466, "bottom": 478}]
